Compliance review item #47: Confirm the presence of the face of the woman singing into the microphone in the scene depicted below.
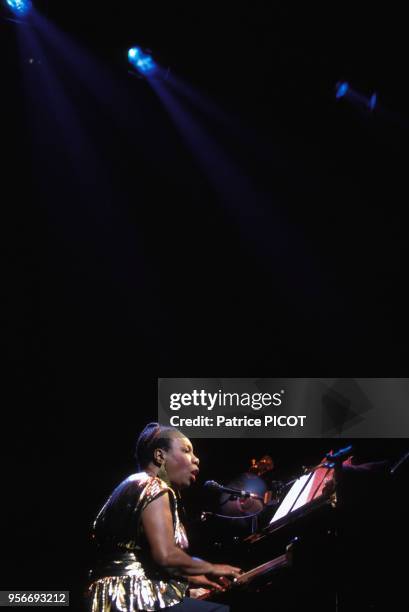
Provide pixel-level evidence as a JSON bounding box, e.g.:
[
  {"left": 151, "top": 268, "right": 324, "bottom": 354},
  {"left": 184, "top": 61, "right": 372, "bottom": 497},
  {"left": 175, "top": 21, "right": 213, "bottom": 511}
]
[{"left": 166, "top": 437, "right": 199, "bottom": 489}]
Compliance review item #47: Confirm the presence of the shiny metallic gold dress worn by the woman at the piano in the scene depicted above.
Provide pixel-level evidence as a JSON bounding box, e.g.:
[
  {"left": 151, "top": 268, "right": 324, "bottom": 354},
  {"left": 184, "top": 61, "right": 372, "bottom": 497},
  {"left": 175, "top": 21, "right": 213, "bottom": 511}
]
[{"left": 89, "top": 472, "right": 188, "bottom": 612}]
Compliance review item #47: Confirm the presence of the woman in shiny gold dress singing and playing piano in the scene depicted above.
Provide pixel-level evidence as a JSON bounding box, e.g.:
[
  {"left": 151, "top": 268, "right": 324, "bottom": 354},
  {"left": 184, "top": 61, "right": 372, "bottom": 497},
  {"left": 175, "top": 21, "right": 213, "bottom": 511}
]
[{"left": 89, "top": 423, "right": 241, "bottom": 612}]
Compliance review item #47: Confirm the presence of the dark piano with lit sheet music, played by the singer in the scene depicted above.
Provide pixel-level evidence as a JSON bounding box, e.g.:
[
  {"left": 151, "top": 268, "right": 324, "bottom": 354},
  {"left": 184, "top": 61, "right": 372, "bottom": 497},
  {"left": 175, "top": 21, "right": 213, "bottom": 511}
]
[{"left": 193, "top": 465, "right": 338, "bottom": 612}]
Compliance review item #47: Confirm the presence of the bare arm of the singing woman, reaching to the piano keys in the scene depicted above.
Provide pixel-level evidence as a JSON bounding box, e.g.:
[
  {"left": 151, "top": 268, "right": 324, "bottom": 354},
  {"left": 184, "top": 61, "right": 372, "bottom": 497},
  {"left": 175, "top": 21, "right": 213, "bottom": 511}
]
[{"left": 141, "top": 494, "right": 241, "bottom": 578}]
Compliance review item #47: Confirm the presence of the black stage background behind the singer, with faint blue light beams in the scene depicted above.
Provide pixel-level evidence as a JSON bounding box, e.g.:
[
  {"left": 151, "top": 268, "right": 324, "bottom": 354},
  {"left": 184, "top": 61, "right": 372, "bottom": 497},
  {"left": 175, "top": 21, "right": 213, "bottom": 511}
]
[{"left": 0, "top": 0, "right": 408, "bottom": 608}]
